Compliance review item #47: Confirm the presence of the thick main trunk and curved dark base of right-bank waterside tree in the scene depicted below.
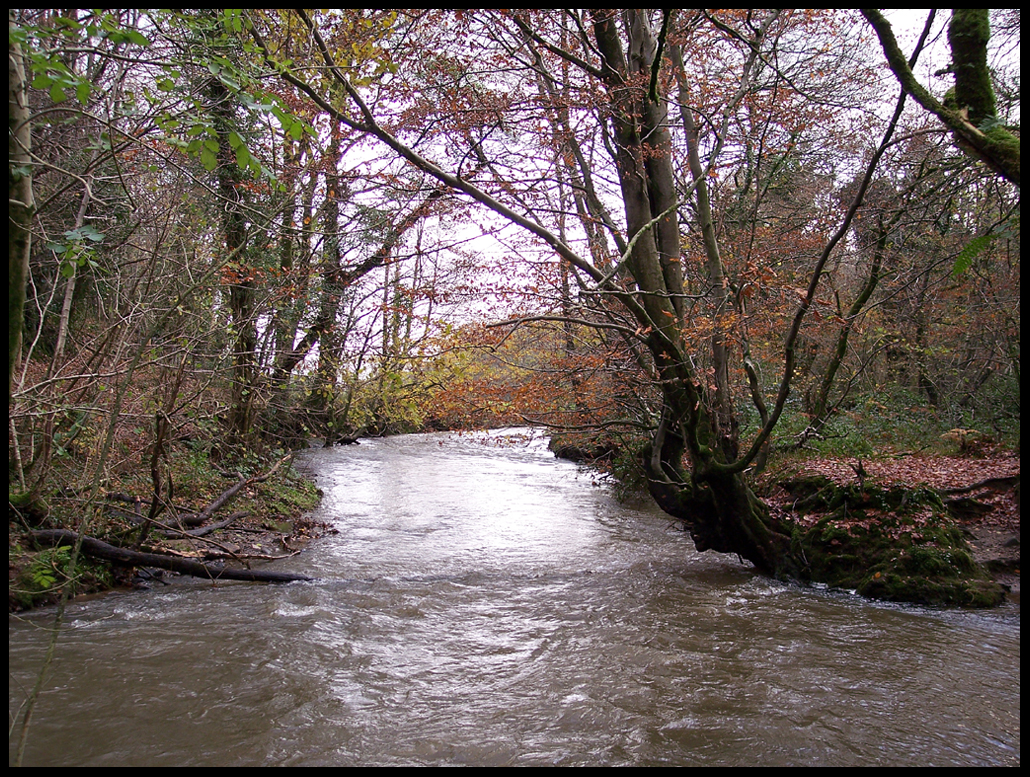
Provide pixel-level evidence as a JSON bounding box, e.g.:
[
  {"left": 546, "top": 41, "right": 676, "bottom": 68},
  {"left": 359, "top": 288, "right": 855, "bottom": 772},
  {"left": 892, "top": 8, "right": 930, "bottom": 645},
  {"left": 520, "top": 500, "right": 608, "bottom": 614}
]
[{"left": 594, "top": 10, "right": 797, "bottom": 577}]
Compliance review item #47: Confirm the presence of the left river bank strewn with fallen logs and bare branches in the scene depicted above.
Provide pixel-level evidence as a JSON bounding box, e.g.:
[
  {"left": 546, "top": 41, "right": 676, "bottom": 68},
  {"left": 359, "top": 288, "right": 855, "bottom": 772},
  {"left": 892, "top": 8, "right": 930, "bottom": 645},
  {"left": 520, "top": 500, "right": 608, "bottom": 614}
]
[{"left": 7, "top": 447, "right": 332, "bottom": 612}]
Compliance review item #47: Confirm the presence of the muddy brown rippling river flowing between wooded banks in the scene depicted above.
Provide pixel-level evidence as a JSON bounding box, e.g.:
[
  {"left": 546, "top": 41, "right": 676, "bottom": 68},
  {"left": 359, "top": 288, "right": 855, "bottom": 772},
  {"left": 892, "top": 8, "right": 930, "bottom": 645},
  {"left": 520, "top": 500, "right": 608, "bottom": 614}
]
[{"left": 8, "top": 432, "right": 1020, "bottom": 767}]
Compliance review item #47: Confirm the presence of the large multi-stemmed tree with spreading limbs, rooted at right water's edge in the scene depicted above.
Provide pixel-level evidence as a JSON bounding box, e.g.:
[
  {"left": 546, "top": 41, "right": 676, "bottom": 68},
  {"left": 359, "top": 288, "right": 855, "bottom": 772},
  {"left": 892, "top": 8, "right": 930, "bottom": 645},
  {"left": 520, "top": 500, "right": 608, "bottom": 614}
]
[{"left": 253, "top": 10, "right": 906, "bottom": 576}]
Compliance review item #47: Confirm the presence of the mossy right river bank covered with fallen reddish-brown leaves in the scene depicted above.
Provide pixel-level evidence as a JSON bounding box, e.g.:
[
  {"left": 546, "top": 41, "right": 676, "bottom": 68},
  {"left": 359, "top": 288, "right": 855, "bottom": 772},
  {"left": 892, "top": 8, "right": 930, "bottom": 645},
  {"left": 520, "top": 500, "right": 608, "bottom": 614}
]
[{"left": 551, "top": 435, "right": 1020, "bottom": 607}]
